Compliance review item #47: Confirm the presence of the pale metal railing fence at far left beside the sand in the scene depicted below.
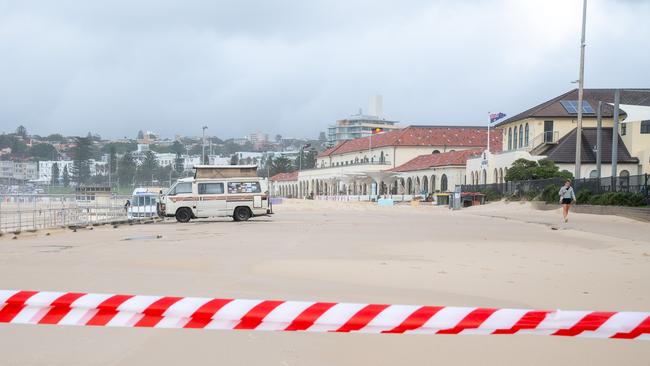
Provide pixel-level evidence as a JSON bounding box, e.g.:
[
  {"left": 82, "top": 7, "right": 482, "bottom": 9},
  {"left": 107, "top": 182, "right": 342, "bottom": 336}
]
[{"left": 0, "top": 194, "right": 128, "bottom": 233}]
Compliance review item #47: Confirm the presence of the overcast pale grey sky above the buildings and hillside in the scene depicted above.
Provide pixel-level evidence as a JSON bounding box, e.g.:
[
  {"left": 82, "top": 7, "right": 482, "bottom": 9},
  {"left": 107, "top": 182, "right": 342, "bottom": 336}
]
[{"left": 0, "top": 0, "right": 650, "bottom": 137}]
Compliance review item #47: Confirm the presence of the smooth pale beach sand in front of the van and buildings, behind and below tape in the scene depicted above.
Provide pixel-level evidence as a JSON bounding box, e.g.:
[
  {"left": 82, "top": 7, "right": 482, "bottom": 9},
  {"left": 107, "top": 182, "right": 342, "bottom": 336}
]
[{"left": 0, "top": 200, "right": 650, "bottom": 365}]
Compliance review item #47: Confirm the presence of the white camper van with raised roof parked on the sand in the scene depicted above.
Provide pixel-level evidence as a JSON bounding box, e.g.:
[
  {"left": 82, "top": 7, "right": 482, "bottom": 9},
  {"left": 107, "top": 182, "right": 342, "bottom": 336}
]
[{"left": 158, "top": 165, "right": 272, "bottom": 222}]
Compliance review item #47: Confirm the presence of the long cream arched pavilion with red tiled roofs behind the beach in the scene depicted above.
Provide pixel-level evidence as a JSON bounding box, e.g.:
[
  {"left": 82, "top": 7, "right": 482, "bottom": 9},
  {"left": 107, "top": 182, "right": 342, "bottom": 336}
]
[{"left": 274, "top": 126, "right": 501, "bottom": 197}]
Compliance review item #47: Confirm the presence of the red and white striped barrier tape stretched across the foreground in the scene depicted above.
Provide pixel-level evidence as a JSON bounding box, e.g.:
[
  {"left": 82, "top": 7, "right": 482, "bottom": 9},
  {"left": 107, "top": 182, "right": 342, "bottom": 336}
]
[{"left": 0, "top": 290, "right": 650, "bottom": 340}]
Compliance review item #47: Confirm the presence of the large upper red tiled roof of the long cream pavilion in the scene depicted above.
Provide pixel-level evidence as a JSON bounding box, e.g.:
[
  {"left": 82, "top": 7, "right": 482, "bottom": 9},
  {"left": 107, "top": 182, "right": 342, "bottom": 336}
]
[{"left": 318, "top": 126, "right": 502, "bottom": 157}]
